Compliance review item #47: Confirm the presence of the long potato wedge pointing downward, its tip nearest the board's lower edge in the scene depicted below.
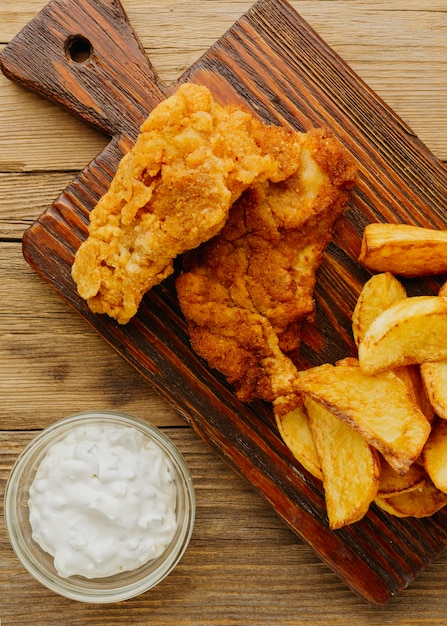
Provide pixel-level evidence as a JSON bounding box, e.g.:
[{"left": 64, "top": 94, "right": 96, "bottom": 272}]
[{"left": 305, "top": 398, "right": 380, "bottom": 530}]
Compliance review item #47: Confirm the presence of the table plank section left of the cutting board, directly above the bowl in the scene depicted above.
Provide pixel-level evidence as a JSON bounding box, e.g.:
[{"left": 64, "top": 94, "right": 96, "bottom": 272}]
[{"left": 0, "top": 242, "right": 184, "bottom": 428}]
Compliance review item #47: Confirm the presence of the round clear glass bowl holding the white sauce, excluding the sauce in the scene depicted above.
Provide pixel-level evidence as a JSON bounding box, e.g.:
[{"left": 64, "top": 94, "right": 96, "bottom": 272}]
[{"left": 5, "top": 411, "right": 195, "bottom": 603}]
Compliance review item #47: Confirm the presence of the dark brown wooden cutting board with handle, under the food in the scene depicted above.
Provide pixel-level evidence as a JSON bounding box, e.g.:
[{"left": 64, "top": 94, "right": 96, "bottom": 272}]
[{"left": 0, "top": 0, "right": 447, "bottom": 604}]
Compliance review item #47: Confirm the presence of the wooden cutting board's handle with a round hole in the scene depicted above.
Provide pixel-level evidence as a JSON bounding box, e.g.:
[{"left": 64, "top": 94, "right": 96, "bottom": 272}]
[{"left": 0, "top": 0, "right": 165, "bottom": 137}]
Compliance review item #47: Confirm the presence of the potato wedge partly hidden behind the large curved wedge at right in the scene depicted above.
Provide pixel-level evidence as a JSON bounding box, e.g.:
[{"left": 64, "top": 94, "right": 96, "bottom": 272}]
[{"left": 352, "top": 272, "right": 407, "bottom": 347}]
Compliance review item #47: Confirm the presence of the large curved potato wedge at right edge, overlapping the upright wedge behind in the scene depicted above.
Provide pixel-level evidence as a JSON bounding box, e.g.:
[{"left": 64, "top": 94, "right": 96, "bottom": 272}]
[{"left": 358, "top": 296, "right": 447, "bottom": 374}]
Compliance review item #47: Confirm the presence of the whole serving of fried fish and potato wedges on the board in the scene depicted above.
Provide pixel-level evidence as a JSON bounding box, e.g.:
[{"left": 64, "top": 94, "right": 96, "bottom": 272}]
[{"left": 72, "top": 84, "right": 447, "bottom": 530}]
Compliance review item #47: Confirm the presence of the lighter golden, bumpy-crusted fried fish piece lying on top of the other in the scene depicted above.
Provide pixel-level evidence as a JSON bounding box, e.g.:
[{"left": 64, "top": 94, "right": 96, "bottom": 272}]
[{"left": 72, "top": 84, "right": 300, "bottom": 324}]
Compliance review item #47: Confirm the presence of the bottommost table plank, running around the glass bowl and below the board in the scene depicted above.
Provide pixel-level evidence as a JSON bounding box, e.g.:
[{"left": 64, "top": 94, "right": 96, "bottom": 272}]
[{"left": 0, "top": 428, "right": 445, "bottom": 626}]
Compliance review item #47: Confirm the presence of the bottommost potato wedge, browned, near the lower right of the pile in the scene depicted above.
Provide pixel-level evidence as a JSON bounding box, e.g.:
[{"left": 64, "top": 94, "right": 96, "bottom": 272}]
[{"left": 374, "top": 482, "right": 447, "bottom": 518}]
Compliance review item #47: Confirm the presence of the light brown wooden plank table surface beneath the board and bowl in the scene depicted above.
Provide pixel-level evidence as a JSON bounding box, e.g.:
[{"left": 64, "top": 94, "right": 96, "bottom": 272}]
[{"left": 0, "top": 0, "right": 447, "bottom": 626}]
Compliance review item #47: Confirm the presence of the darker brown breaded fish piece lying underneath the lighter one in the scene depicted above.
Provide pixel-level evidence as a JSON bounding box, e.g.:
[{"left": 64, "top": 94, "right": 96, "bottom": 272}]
[{"left": 176, "top": 129, "right": 357, "bottom": 406}]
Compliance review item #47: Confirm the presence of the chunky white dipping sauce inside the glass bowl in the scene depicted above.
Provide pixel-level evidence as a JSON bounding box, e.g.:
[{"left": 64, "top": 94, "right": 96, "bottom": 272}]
[{"left": 29, "top": 424, "right": 177, "bottom": 578}]
